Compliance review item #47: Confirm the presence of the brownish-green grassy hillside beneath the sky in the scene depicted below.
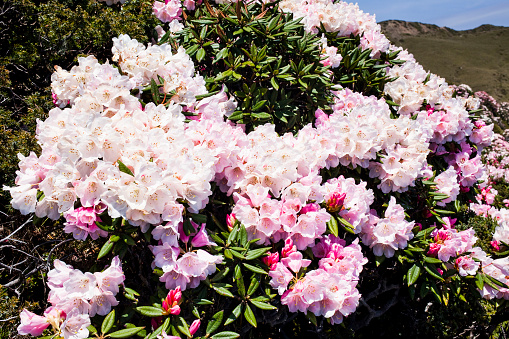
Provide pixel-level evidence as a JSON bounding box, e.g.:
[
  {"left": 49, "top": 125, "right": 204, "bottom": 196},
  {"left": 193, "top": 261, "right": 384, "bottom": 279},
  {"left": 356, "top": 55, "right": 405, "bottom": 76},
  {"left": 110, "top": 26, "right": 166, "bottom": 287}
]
[{"left": 380, "top": 20, "right": 509, "bottom": 101}]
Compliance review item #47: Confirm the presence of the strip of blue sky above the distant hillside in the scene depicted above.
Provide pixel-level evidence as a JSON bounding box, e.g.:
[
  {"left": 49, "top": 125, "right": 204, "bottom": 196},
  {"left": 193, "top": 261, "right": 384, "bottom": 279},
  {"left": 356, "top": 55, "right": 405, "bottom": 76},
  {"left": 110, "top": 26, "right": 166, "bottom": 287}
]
[{"left": 352, "top": 0, "right": 509, "bottom": 30}]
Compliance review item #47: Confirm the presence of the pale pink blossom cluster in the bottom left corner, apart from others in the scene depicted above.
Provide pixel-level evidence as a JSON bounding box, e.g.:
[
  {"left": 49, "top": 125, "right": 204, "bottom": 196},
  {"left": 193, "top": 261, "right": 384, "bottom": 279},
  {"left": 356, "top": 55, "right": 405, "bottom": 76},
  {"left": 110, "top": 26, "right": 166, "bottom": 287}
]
[{"left": 18, "top": 257, "right": 125, "bottom": 339}]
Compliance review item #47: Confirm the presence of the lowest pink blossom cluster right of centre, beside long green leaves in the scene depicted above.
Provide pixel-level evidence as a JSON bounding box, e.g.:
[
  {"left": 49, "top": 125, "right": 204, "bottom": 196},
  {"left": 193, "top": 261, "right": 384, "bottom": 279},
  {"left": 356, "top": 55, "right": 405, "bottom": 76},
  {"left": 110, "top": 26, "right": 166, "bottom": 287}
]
[{"left": 265, "top": 235, "right": 367, "bottom": 324}]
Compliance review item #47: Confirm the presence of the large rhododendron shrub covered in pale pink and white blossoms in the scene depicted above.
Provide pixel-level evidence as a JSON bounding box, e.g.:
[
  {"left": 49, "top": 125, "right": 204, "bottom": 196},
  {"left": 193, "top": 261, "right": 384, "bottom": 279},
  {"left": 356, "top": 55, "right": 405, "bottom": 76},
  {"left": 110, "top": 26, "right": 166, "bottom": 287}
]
[{"left": 5, "top": 0, "right": 509, "bottom": 338}]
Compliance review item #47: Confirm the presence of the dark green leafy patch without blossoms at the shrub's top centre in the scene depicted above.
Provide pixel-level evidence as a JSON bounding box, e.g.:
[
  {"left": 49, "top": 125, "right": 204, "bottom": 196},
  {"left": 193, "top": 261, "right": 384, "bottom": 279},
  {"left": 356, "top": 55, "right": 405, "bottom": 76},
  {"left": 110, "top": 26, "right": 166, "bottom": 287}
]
[{"left": 173, "top": 2, "right": 397, "bottom": 133}]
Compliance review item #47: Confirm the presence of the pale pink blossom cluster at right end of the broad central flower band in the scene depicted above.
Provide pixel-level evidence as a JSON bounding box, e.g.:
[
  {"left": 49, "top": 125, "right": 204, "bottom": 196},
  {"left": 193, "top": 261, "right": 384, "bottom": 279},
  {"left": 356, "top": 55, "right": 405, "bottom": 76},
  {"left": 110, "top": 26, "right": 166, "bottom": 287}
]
[{"left": 316, "top": 89, "right": 432, "bottom": 193}]
